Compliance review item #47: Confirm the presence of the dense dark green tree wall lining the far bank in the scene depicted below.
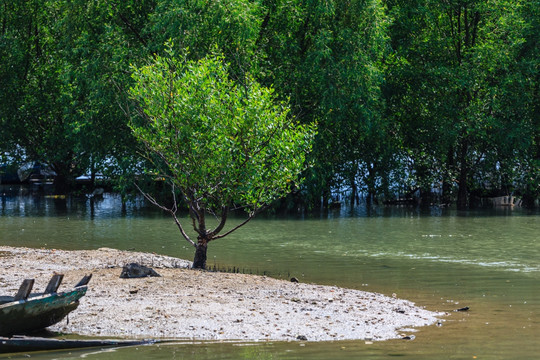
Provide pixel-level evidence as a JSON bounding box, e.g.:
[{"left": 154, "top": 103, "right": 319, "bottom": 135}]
[{"left": 0, "top": 0, "right": 540, "bottom": 208}]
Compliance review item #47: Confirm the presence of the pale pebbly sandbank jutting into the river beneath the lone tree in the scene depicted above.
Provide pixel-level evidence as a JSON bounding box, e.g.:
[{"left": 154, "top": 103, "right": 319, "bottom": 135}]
[{"left": 0, "top": 246, "right": 443, "bottom": 341}]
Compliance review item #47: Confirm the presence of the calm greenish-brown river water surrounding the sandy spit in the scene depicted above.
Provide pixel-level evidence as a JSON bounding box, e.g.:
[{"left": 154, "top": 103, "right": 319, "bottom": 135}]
[{"left": 0, "top": 191, "right": 540, "bottom": 359}]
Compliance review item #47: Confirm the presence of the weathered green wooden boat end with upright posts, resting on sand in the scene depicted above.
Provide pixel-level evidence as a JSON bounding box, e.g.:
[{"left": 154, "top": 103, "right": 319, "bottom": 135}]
[{"left": 0, "top": 274, "right": 92, "bottom": 336}]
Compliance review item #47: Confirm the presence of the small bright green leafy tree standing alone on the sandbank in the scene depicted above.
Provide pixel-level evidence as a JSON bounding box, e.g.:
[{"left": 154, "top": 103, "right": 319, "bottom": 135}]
[{"left": 130, "top": 53, "right": 315, "bottom": 268}]
